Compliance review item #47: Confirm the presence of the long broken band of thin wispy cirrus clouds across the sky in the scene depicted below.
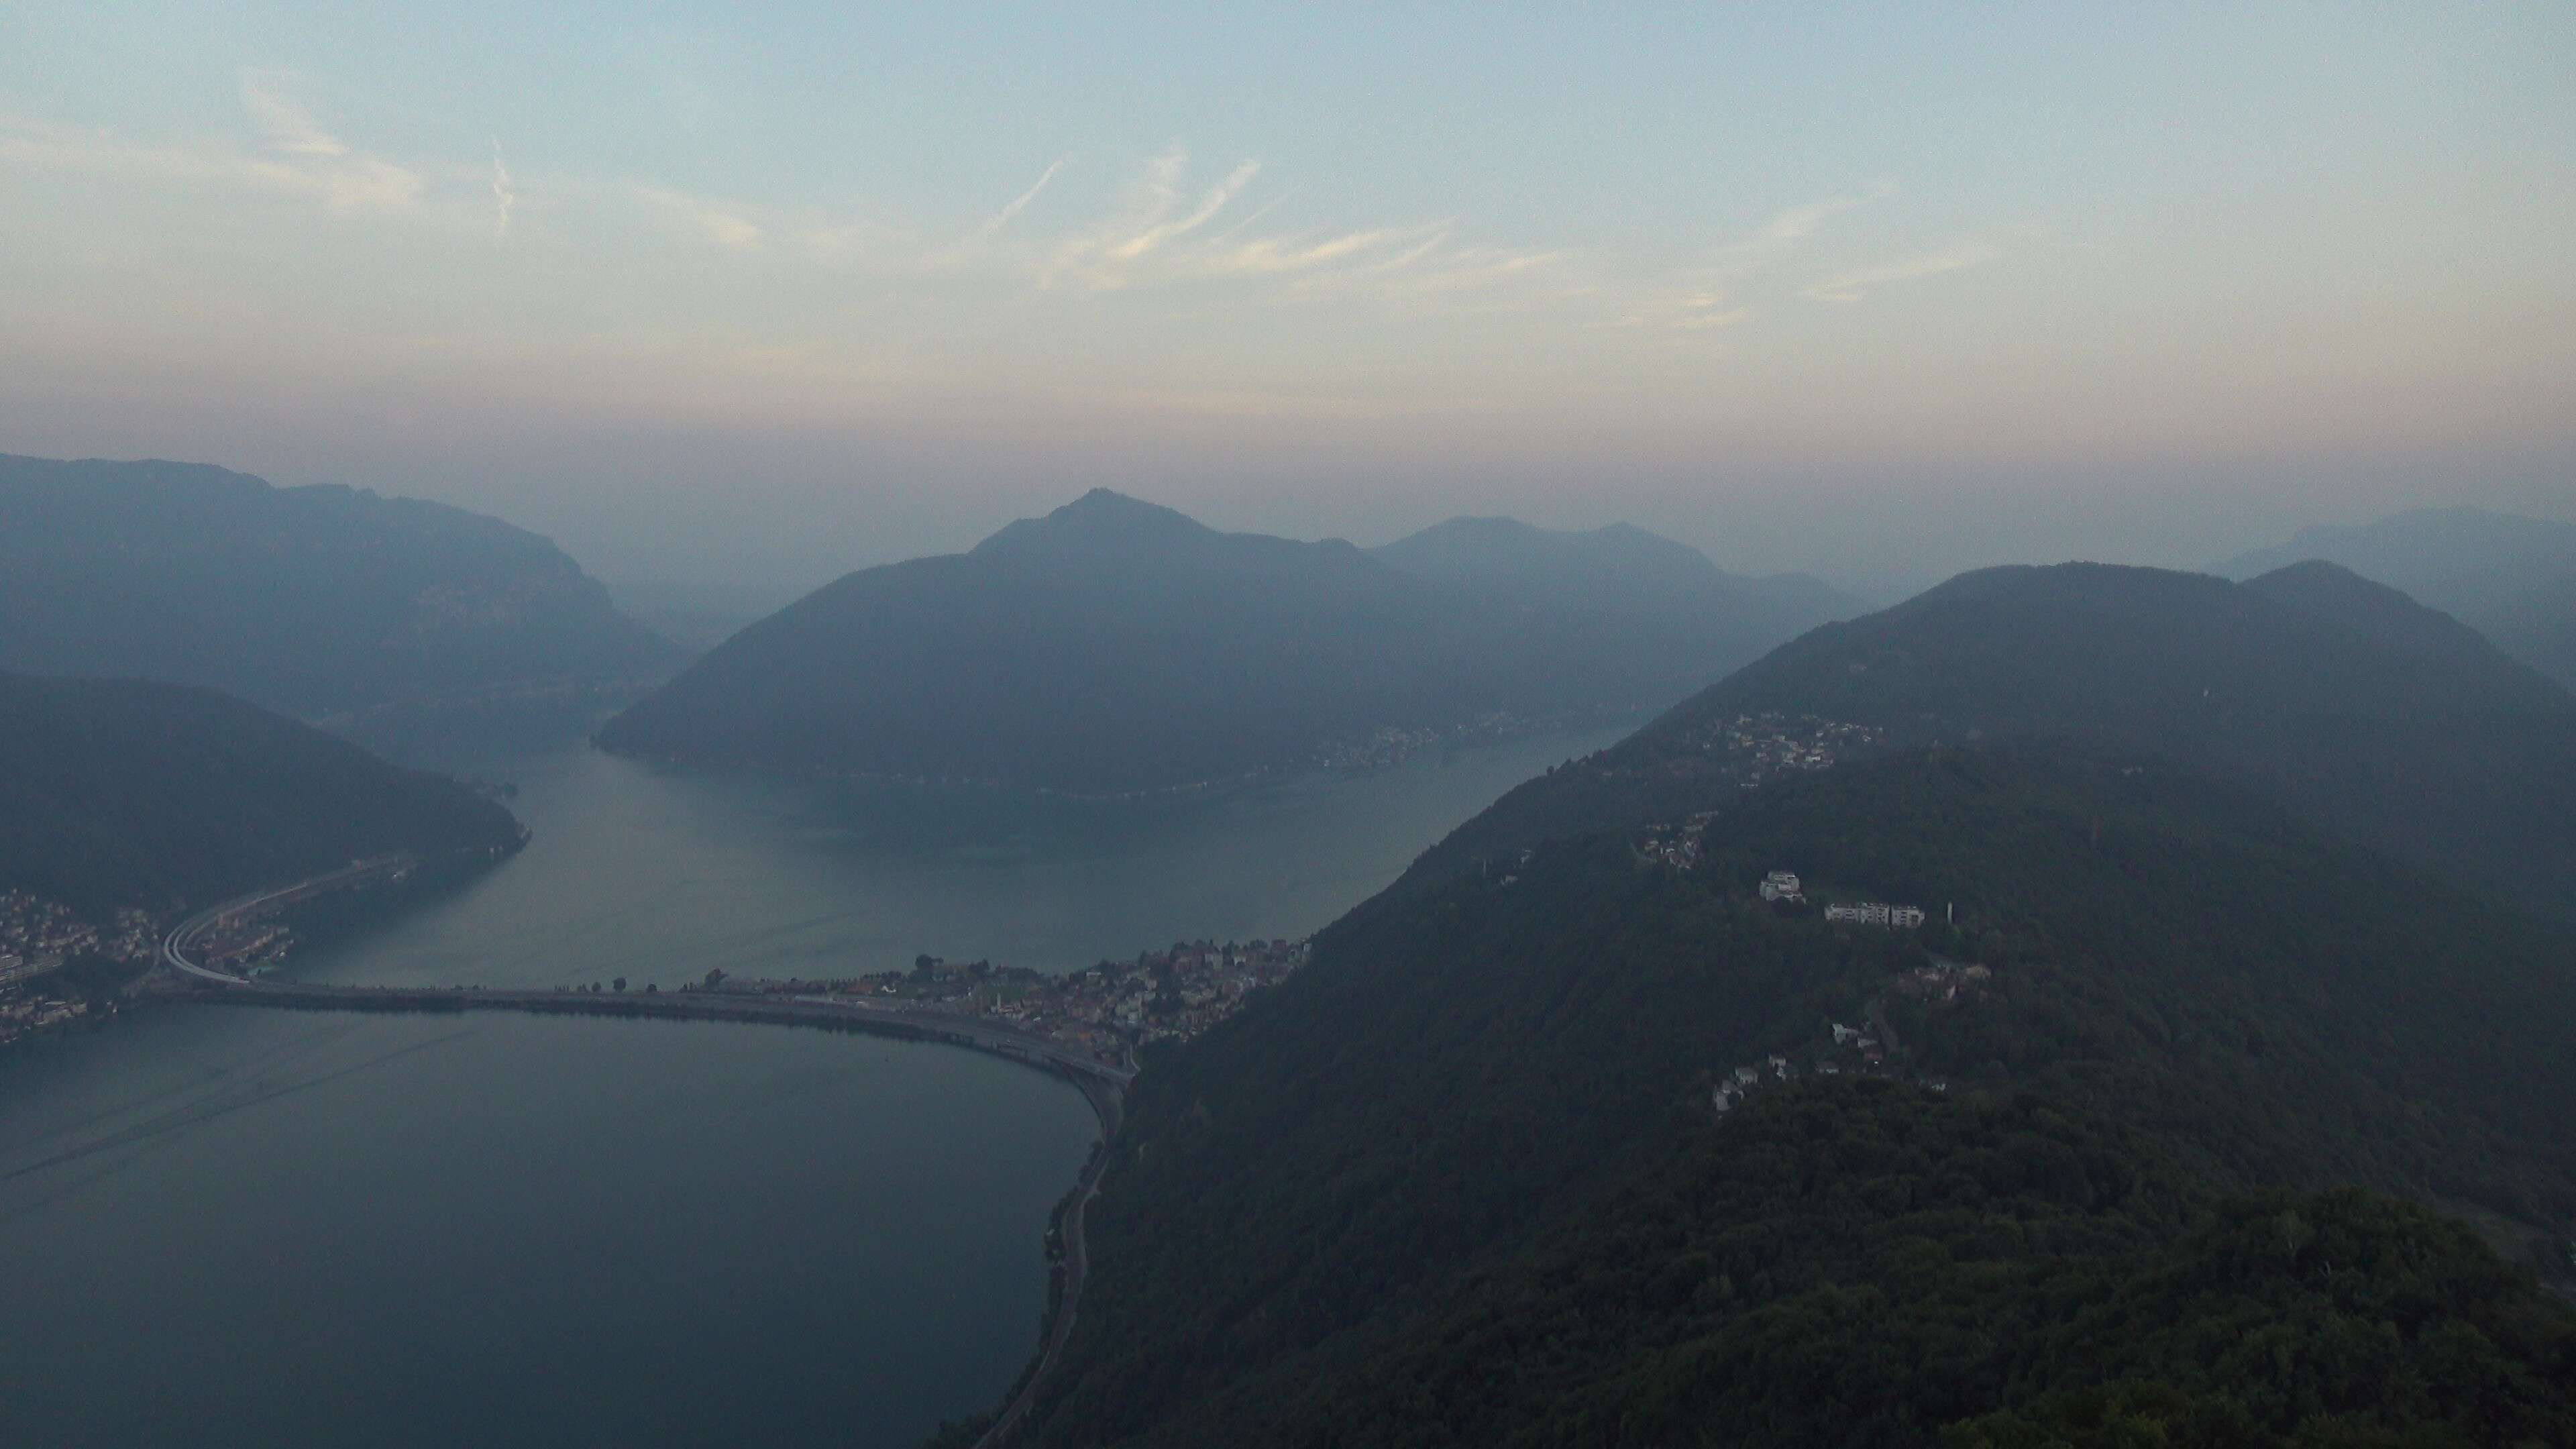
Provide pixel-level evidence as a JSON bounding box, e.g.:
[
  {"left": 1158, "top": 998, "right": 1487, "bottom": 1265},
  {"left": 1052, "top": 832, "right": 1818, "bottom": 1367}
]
[{"left": 0, "top": 72, "right": 1999, "bottom": 347}]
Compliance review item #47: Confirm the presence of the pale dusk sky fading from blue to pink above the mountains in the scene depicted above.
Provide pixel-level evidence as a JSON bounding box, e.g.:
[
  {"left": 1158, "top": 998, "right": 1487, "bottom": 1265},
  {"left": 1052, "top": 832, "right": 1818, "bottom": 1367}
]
[{"left": 0, "top": 0, "right": 2576, "bottom": 601}]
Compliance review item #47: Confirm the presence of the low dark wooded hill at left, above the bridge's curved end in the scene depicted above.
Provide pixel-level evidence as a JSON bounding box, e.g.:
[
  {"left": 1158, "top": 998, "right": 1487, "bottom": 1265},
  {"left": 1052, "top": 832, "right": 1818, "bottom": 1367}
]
[{"left": 0, "top": 676, "right": 521, "bottom": 920}]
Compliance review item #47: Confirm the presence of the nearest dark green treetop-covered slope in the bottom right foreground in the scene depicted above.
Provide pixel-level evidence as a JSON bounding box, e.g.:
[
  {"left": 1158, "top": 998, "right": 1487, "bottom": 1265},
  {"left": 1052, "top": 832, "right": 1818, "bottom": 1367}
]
[{"left": 1252, "top": 1080, "right": 2576, "bottom": 1449}]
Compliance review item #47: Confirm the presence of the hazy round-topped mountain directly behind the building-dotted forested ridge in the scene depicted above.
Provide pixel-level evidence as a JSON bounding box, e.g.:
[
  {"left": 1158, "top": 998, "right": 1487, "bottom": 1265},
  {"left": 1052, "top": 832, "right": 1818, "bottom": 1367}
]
[{"left": 1417, "top": 562, "right": 2576, "bottom": 910}]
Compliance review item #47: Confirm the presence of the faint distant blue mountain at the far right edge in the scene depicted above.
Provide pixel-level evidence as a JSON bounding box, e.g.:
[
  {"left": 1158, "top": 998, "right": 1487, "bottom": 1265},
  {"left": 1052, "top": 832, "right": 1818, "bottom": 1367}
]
[{"left": 2210, "top": 508, "right": 2576, "bottom": 688}]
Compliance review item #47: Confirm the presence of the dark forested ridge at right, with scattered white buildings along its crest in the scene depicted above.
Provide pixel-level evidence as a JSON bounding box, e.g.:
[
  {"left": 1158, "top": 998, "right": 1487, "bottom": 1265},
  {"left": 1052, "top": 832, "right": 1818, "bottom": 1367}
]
[{"left": 1010, "top": 745, "right": 2576, "bottom": 1444}]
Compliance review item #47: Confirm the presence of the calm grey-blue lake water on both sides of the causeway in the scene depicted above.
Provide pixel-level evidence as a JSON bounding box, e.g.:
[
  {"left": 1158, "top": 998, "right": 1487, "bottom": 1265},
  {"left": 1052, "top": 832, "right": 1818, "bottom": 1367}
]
[{"left": 0, "top": 733, "right": 1615, "bottom": 1449}]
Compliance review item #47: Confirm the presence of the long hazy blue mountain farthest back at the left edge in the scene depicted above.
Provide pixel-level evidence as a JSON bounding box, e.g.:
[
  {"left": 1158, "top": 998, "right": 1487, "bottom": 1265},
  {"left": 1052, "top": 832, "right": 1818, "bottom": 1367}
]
[{"left": 0, "top": 456, "right": 672, "bottom": 716}]
